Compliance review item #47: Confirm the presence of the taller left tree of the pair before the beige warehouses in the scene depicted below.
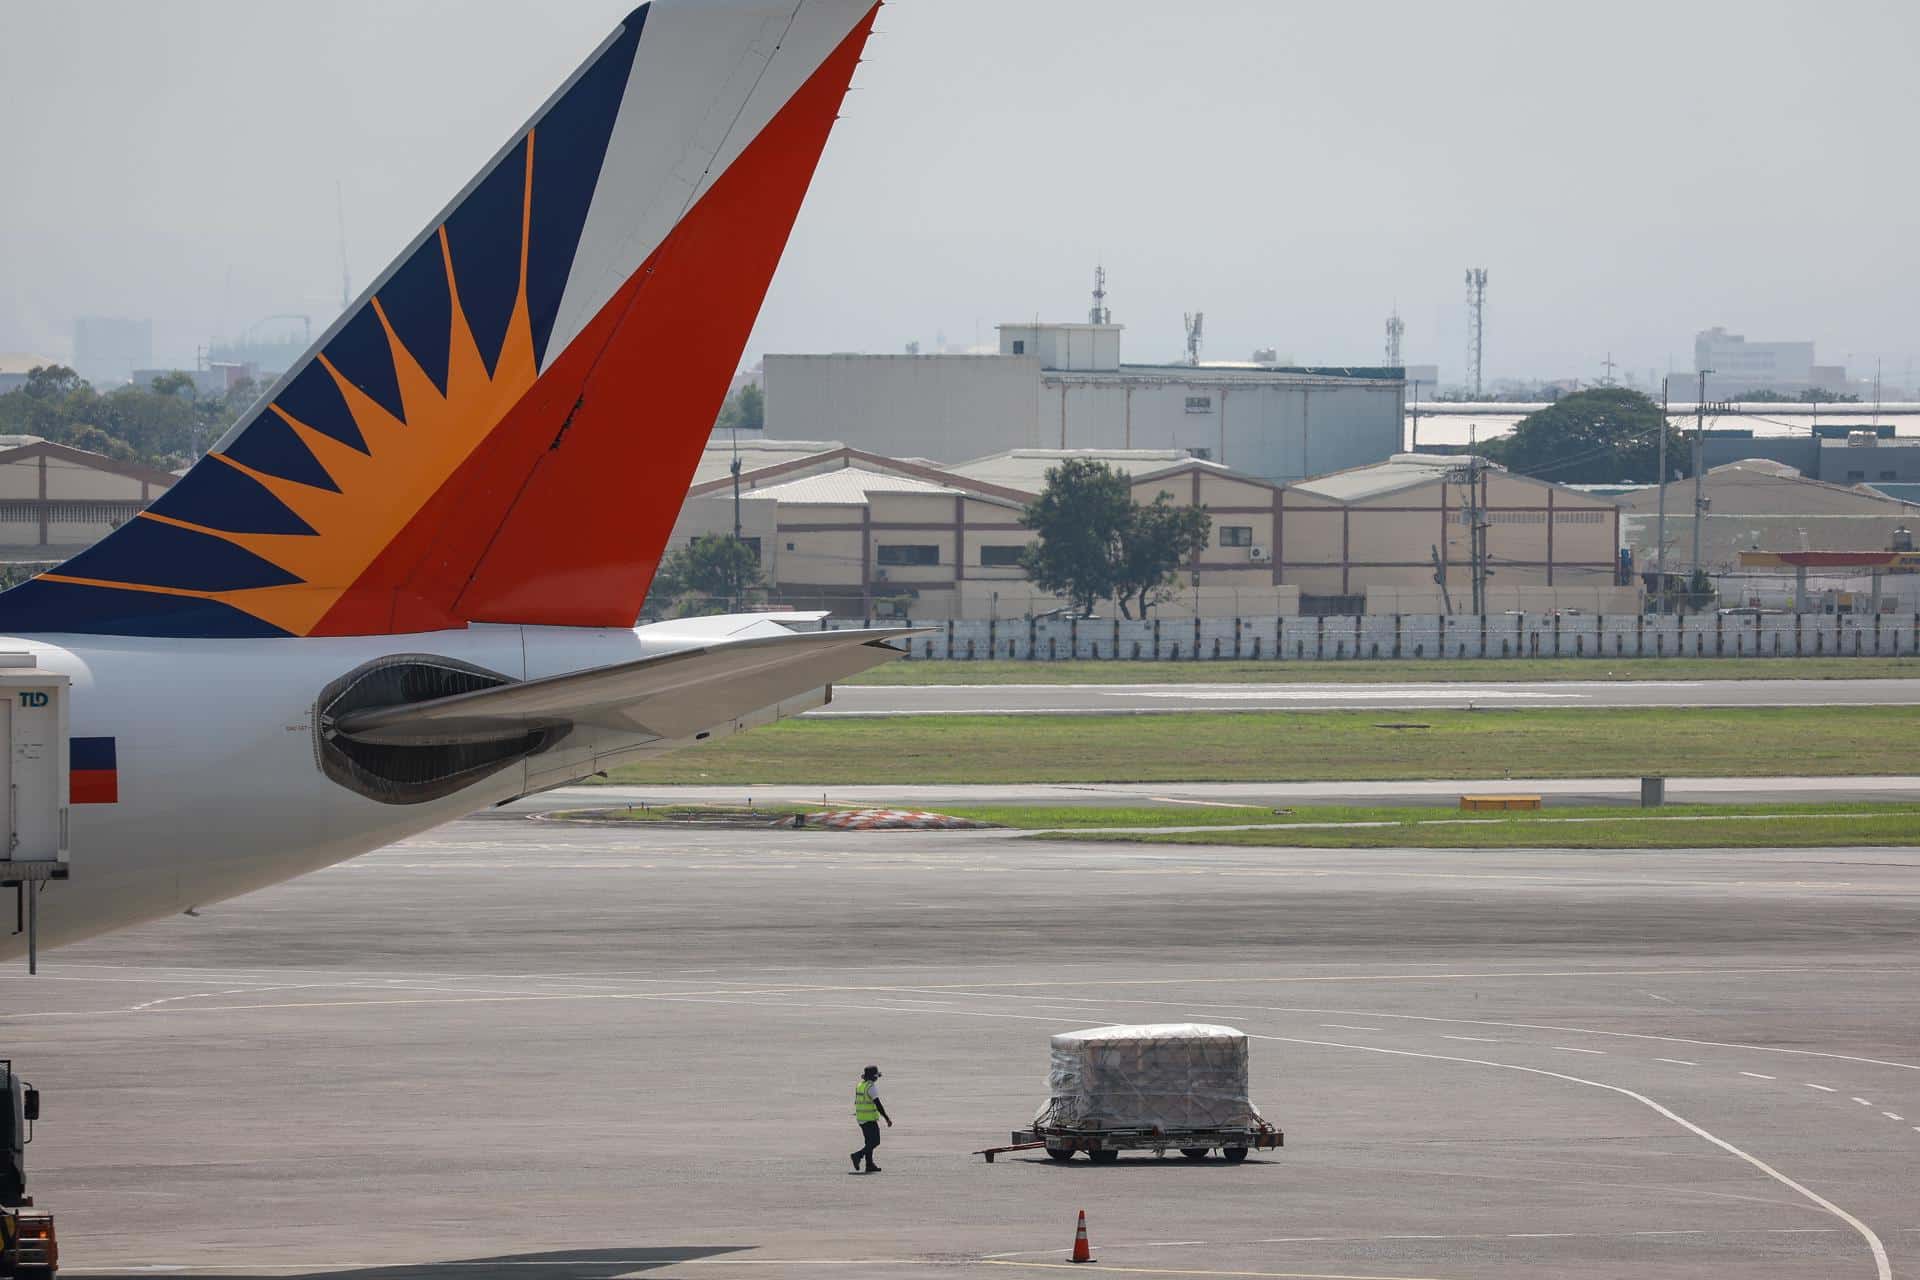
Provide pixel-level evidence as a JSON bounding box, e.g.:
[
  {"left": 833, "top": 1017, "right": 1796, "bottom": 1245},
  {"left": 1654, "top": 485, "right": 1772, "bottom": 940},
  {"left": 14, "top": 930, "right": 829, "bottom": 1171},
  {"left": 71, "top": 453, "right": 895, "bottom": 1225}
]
[{"left": 1020, "top": 459, "right": 1133, "bottom": 614}]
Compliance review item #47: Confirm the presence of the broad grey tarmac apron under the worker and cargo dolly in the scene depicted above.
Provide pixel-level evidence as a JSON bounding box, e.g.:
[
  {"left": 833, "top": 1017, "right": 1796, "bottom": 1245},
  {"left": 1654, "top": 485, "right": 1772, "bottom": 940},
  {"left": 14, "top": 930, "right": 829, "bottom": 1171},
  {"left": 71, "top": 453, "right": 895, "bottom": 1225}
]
[{"left": 0, "top": 814, "right": 1920, "bottom": 1280}]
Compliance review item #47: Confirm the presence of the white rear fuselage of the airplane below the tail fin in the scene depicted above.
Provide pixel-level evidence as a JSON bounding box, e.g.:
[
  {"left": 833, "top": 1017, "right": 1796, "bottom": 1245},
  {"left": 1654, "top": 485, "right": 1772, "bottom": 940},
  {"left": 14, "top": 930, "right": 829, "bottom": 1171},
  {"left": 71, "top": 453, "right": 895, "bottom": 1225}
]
[{"left": 0, "top": 624, "right": 837, "bottom": 956}]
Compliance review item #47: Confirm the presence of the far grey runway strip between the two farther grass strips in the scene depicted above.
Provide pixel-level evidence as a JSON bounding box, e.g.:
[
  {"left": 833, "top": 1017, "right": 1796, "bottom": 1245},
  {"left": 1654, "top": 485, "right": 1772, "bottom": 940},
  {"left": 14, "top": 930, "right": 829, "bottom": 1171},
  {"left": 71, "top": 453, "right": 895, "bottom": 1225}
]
[{"left": 808, "top": 664, "right": 1920, "bottom": 718}]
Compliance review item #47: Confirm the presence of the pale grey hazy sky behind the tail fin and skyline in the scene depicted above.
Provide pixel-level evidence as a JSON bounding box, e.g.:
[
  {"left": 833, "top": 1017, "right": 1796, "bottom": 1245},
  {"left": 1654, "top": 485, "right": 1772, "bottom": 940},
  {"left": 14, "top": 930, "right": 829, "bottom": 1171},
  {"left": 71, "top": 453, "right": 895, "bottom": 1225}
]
[{"left": 0, "top": 0, "right": 1920, "bottom": 382}]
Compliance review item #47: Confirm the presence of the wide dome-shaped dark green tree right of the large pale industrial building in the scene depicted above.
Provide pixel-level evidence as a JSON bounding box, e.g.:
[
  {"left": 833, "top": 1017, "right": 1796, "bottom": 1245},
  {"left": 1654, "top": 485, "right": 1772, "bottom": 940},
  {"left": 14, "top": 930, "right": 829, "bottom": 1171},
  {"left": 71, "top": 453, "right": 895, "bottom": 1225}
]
[{"left": 1480, "top": 386, "right": 1688, "bottom": 484}]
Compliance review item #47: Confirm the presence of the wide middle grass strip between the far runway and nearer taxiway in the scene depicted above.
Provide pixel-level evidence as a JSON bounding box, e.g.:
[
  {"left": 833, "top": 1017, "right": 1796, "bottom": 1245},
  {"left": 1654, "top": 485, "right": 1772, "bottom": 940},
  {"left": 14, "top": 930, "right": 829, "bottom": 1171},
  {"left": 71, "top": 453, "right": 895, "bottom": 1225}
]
[{"left": 607, "top": 706, "right": 1920, "bottom": 785}]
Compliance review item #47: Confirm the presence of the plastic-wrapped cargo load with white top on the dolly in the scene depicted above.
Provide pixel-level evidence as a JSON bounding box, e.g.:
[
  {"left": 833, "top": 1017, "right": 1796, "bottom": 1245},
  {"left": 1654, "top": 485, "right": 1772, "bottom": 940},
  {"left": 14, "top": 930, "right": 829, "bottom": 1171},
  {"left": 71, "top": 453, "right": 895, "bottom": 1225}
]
[{"left": 1033, "top": 1023, "right": 1265, "bottom": 1132}]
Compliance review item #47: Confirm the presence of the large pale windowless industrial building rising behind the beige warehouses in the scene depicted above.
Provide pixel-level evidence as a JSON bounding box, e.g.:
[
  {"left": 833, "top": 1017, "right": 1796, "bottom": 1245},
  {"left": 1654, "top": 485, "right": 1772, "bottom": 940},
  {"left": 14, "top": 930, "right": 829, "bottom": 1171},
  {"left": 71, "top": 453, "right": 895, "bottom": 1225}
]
[{"left": 766, "top": 324, "right": 1405, "bottom": 482}]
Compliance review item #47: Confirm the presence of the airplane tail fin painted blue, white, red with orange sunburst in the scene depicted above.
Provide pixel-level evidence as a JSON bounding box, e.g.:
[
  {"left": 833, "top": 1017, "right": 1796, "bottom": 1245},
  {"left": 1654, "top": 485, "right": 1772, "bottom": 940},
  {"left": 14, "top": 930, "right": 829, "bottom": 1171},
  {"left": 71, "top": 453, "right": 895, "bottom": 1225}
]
[{"left": 0, "top": 0, "right": 877, "bottom": 637}]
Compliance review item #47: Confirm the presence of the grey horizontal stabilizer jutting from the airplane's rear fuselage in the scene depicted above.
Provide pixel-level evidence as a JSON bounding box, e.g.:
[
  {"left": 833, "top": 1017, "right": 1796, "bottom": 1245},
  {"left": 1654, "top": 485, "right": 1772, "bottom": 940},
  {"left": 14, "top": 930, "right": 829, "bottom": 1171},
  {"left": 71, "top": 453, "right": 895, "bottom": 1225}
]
[{"left": 330, "top": 628, "right": 914, "bottom": 747}]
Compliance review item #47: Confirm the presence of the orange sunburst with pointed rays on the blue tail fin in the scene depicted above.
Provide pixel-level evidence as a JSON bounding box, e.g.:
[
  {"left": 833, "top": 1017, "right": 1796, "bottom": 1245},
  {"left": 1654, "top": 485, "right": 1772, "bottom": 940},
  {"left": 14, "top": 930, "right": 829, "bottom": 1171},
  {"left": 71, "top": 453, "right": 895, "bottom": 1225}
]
[{"left": 169, "top": 134, "right": 540, "bottom": 635}]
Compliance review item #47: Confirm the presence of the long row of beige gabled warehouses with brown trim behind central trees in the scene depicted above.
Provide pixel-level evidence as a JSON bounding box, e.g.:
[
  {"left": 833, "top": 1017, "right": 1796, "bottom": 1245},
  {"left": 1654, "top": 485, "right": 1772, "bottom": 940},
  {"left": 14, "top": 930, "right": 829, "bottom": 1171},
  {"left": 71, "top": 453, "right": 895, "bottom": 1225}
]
[{"left": 674, "top": 441, "right": 1638, "bottom": 618}]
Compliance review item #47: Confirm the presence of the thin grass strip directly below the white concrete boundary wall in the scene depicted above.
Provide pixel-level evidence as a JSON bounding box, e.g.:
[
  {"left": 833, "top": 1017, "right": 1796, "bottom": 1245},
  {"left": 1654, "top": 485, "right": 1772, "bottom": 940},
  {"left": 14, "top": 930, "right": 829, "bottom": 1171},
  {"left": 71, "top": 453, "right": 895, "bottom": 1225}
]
[{"left": 845, "top": 658, "right": 1920, "bottom": 685}]
